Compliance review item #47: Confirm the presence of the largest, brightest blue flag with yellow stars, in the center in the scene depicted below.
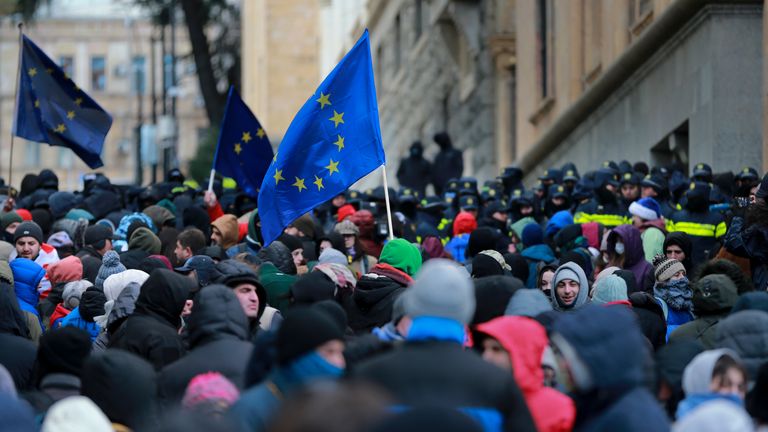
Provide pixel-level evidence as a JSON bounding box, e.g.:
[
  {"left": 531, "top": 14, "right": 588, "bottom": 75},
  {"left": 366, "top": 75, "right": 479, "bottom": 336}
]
[{"left": 259, "top": 30, "right": 385, "bottom": 245}]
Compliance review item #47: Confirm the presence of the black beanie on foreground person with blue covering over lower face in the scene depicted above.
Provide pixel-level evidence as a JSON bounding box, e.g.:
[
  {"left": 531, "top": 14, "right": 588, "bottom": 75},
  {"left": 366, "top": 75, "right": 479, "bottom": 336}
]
[{"left": 275, "top": 307, "right": 344, "bottom": 366}]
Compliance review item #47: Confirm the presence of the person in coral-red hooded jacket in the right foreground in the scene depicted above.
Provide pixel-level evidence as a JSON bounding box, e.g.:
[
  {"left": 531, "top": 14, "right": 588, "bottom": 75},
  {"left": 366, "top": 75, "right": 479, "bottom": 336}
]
[{"left": 473, "top": 316, "right": 576, "bottom": 432}]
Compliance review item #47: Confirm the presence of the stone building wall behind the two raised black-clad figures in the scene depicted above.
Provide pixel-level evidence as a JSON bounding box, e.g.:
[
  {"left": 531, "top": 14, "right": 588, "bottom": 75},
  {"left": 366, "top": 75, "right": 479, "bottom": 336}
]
[{"left": 365, "top": 0, "right": 514, "bottom": 189}]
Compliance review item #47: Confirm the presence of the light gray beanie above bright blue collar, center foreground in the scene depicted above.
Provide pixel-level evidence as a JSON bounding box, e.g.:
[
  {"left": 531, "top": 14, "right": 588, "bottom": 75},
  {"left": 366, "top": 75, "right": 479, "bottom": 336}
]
[{"left": 402, "top": 259, "right": 475, "bottom": 325}]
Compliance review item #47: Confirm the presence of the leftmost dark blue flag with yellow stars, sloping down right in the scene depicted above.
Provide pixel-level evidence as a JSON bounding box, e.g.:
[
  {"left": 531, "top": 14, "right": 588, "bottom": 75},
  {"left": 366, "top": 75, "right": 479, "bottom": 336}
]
[{"left": 13, "top": 36, "right": 112, "bottom": 169}]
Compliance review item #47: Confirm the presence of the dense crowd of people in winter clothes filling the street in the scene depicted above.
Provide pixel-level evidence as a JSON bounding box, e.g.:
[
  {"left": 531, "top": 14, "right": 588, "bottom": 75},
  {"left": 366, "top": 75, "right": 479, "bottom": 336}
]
[{"left": 0, "top": 141, "right": 768, "bottom": 432}]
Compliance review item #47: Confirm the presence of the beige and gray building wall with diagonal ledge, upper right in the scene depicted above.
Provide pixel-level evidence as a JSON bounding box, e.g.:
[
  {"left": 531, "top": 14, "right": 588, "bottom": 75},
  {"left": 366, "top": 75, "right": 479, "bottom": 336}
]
[{"left": 517, "top": 0, "right": 763, "bottom": 182}]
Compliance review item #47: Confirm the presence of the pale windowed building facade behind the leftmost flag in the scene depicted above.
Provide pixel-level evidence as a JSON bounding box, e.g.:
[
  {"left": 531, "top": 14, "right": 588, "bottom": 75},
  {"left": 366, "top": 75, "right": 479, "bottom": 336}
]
[{"left": 0, "top": 14, "right": 208, "bottom": 189}]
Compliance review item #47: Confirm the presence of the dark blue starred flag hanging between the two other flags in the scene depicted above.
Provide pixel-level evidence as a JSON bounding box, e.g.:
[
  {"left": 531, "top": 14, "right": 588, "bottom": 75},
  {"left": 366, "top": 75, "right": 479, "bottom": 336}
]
[{"left": 213, "top": 87, "right": 274, "bottom": 198}]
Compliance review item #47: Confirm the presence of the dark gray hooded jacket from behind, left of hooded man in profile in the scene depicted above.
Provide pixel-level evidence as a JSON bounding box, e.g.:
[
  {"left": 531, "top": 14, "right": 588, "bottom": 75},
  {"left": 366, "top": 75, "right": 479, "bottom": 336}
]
[{"left": 158, "top": 285, "right": 253, "bottom": 406}]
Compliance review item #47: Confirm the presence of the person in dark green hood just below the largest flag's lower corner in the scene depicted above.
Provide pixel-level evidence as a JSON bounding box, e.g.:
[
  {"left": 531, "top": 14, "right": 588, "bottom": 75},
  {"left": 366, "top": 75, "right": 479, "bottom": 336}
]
[{"left": 257, "top": 241, "right": 296, "bottom": 311}]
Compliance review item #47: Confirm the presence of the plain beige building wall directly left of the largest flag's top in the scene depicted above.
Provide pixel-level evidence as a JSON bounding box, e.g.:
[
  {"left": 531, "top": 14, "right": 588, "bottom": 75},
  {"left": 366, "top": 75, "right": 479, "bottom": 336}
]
[{"left": 241, "top": 0, "right": 326, "bottom": 146}]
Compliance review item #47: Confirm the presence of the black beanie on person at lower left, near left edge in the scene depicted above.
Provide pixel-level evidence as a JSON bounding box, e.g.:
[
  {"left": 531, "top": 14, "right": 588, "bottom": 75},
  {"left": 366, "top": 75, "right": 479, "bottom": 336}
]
[{"left": 36, "top": 326, "right": 91, "bottom": 378}]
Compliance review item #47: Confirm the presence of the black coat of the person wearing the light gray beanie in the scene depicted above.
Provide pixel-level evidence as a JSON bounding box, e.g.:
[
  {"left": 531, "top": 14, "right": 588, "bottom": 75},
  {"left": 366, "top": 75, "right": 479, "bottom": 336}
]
[{"left": 351, "top": 341, "right": 536, "bottom": 431}]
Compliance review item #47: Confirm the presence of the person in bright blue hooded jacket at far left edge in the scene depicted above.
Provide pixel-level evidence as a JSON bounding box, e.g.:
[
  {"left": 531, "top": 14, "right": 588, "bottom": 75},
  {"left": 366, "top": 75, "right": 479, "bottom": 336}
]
[{"left": 10, "top": 258, "right": 45, "bottom": 343}]
